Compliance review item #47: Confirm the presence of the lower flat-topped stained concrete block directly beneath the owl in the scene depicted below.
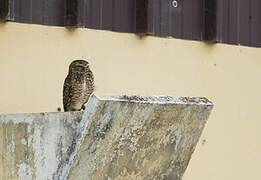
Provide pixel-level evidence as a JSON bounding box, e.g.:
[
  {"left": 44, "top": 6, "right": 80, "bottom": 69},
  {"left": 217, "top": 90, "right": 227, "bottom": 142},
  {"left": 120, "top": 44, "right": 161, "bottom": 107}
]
[{"left": 0, "top": 112, "right": 82, "bottom": 180}]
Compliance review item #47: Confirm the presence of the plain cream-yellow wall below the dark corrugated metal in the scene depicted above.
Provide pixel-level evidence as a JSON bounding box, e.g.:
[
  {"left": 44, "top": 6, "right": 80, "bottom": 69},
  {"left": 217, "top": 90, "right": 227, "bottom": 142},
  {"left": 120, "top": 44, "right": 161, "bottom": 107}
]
[{"left": 0, "top": 23, "right": 261, "bottom": 180}]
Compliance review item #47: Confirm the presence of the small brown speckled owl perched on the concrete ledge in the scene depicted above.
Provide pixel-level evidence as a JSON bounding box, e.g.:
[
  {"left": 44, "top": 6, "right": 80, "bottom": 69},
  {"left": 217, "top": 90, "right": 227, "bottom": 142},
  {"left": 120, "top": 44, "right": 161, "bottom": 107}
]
[{"left": 63, "top": 60, "right": 94, "bottom": 111}]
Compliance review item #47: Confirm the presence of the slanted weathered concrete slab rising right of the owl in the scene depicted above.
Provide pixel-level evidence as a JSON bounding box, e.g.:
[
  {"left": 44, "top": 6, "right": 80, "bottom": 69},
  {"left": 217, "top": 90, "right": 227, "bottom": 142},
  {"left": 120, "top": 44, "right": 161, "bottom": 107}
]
[{"left": 67, "top": 96, "right": 213, "bottom": 180}]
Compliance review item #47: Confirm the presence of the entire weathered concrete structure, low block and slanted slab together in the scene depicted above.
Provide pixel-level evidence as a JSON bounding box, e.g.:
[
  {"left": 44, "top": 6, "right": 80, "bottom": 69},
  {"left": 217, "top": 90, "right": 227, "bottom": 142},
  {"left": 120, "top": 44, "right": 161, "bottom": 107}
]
[{"left": 0, "top": 96, "right": 213, "bottom": 180}]
